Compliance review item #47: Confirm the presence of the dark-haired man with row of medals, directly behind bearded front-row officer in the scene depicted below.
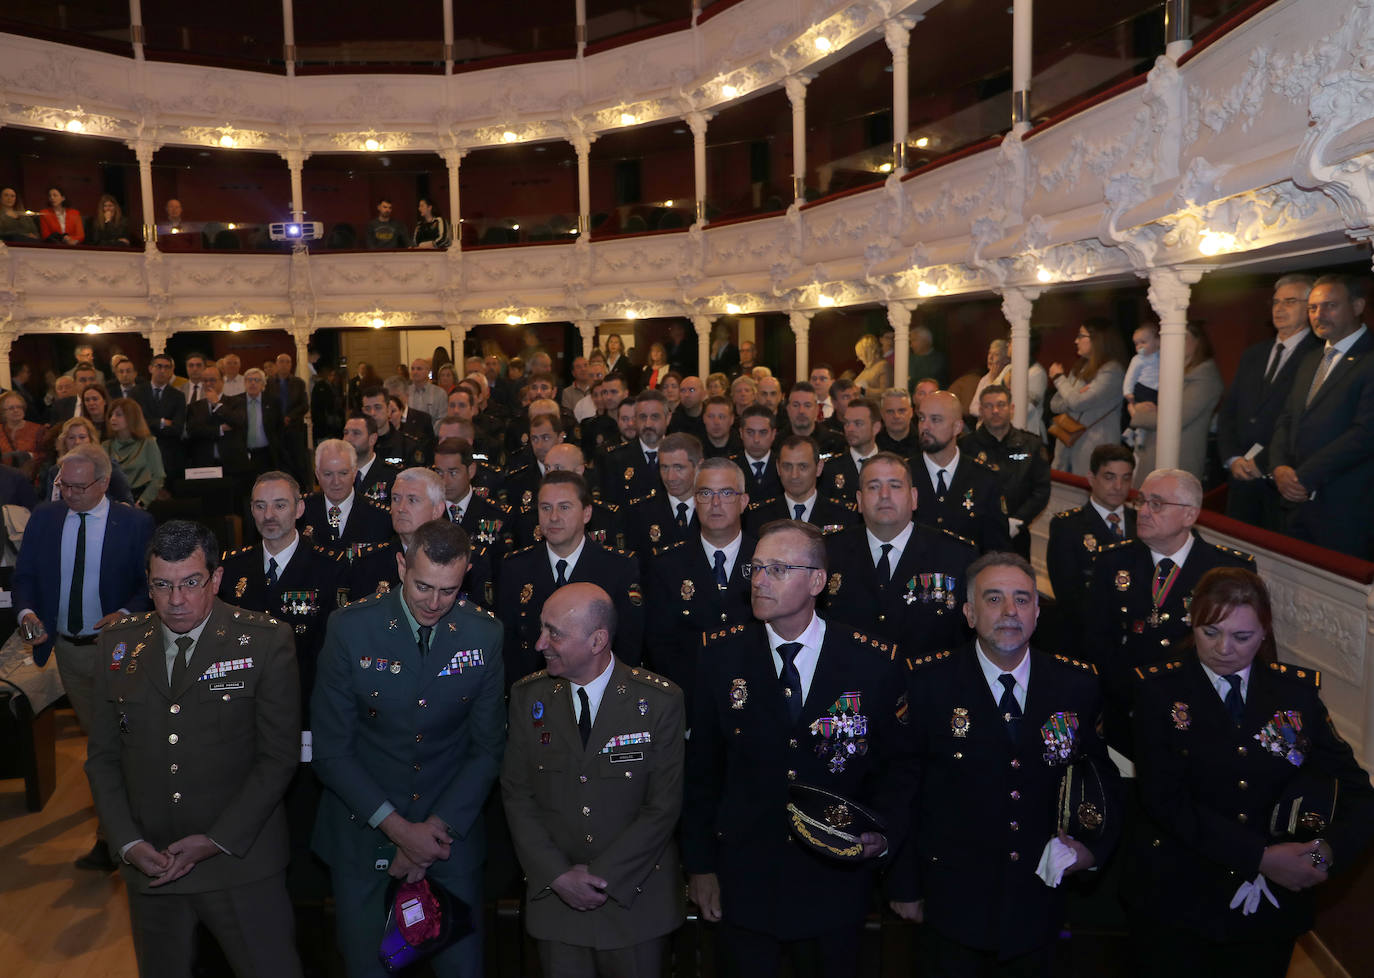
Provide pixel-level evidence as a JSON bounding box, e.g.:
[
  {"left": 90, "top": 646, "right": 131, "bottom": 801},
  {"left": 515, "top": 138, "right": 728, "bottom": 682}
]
[{"left": 822, "top": 452, "right": 978, "bottom": 657}]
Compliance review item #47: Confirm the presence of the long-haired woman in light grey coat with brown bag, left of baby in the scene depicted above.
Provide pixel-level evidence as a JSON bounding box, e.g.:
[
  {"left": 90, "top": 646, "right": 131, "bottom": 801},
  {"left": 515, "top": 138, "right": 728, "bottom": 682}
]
[{"left": 1050, "top": 317, "right": 1125, "bottom": 475}]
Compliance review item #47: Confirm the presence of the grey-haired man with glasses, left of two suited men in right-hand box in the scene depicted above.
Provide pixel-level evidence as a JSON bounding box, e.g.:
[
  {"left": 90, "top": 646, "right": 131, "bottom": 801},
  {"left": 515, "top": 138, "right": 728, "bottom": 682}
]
[{"left": 1216, "top": 275, "right": 1322, "bottom": 530}]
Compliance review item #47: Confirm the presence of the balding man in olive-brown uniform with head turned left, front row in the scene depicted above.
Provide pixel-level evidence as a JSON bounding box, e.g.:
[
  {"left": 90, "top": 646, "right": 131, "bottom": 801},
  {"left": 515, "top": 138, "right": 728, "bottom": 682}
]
[{"left": 502, "top": 584, "right": 686, "bottom": 978}]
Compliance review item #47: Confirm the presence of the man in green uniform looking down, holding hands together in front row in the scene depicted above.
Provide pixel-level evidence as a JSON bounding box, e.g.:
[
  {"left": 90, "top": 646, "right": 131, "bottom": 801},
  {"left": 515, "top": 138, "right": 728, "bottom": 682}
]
[{"left": 311, "top": 519, "right": 506, "bottom": 978}]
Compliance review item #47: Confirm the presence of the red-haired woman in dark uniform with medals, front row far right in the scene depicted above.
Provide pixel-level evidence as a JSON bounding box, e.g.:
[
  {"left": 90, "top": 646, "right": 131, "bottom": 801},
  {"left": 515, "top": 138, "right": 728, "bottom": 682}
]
[{"left": 1124, "top": 567, "right": 1374, "bottom": 978}]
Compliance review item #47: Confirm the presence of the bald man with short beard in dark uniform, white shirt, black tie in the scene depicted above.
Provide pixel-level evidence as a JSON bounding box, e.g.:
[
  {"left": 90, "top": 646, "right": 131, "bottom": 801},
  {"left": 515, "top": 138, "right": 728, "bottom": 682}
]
[{"left": 911, "top": 390, "right": 1011, "bottom": 554}]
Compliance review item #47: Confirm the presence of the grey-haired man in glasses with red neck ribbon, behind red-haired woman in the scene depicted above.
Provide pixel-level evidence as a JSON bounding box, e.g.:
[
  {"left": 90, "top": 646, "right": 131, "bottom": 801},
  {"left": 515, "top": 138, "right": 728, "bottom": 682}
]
[{"left": 1083, "top": 468, "right": 1254, "bottom": 757}]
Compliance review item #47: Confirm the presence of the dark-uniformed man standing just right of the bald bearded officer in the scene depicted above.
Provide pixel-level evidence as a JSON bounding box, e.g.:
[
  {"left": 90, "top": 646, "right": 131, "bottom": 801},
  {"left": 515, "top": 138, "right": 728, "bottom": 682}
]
[{"left": 959, "top": 383, "right": 1050, "bottom": 560}]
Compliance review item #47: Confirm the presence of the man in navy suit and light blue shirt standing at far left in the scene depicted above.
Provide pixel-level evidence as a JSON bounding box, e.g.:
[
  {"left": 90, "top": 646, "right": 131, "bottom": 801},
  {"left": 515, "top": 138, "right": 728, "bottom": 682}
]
[{"left": 14, "top": 445, "right": 153, "bottom": 871}]
